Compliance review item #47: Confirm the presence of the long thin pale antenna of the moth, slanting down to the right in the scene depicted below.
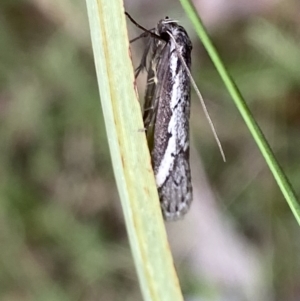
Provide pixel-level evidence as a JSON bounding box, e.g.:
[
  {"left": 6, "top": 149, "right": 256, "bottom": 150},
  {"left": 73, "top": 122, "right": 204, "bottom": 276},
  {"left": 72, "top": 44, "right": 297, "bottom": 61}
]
[{"left": 167, "top": 31, "right": 226, "bottom": 162}]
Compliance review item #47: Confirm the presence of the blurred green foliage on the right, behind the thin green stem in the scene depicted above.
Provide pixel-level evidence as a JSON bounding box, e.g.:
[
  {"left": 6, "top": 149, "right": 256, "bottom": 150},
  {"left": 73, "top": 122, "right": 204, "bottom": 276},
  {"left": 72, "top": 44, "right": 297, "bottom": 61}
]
[{"left": 193, "top": 6, "right": 300, "bottom": 300}]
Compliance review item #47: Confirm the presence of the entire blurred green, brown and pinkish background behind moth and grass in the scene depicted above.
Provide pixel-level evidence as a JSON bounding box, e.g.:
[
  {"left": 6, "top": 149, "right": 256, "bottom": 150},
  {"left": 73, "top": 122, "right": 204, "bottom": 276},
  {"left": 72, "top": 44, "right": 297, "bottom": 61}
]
[{"left": 0, "top": 0, "right": 300, "bottom": 301}]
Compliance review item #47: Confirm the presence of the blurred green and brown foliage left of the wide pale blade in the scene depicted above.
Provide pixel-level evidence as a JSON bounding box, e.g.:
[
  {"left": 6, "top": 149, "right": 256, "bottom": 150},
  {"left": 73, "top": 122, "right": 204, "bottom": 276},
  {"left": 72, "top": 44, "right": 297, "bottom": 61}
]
[{"left": 0, "top": 1, "right": 139, "bottom": 300}]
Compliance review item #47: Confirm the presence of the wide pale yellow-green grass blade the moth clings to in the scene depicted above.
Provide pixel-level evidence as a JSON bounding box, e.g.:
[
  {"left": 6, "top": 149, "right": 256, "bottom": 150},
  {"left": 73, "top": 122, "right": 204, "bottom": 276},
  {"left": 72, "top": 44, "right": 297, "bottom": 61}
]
[{"left": 86, "top": 0, "right": 183, "bottom": 301}]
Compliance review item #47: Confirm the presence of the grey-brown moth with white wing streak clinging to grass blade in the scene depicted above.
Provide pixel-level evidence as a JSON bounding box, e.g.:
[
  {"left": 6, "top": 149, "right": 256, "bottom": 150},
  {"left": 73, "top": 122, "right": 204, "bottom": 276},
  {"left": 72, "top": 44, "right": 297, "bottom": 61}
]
[{"left": 126, "top": 13, "right": 225, "bottom": 221}]
